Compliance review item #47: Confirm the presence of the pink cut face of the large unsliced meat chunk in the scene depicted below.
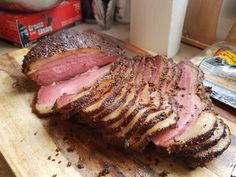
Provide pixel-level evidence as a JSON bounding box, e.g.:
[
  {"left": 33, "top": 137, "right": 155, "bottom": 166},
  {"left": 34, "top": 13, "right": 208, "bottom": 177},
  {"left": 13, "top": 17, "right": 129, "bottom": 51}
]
[{"left": 30, "top": 53, "right": 118, "bottom": 85}]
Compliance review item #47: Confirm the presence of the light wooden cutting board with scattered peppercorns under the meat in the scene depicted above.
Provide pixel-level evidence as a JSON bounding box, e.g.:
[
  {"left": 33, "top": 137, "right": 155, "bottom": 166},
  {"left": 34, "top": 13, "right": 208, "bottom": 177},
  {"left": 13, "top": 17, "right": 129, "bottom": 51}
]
[{"left": 0, "top": 46, "right": 236, "bottom": 177}]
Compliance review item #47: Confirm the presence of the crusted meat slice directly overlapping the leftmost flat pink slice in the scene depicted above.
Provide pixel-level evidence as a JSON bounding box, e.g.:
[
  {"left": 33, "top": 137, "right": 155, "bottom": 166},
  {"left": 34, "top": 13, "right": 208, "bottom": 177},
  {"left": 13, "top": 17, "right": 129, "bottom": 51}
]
[{"left": 55, "top": 59, "right": 130, "bottom": 117}]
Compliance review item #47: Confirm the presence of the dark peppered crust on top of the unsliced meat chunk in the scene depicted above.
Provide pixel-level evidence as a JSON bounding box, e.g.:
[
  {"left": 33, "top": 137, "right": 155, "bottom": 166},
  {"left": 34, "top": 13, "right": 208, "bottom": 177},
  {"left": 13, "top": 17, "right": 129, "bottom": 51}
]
[{"left": 22, "top": 30, "right": 125, "bottom": 74}]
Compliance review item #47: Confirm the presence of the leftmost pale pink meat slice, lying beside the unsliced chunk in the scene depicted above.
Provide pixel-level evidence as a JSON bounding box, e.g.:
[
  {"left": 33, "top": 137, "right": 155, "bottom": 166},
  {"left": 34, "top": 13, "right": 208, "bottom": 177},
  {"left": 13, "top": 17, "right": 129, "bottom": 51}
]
[{"left": 35, "top": 65, "right": 111, "bottom": 114}]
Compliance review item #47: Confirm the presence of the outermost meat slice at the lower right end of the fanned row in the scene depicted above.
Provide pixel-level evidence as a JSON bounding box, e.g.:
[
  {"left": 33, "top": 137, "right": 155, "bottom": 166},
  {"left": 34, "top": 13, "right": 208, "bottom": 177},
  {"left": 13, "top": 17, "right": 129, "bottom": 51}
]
[{"left": 183, "top": 125, "right": 231, "bottom": 168}]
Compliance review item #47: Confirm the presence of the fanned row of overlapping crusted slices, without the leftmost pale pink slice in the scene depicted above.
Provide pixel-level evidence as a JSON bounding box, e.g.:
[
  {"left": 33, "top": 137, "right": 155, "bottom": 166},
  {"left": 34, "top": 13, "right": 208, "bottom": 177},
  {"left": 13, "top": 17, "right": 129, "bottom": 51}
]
[{"left": 50, "top": 56, "right": 230, "bottom": 165}]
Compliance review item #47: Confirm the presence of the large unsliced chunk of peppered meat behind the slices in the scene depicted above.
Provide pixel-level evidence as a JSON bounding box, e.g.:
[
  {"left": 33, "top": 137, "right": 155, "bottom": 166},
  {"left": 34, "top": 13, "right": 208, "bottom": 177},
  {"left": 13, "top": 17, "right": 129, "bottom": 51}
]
[{"left": 22, "top": 30, "right": 124, "bottom": 85}]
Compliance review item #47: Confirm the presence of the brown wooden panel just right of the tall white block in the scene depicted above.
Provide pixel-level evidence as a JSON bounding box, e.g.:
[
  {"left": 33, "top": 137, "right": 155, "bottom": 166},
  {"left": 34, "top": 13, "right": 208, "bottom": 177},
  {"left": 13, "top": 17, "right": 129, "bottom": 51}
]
[{"left": 183, "top": 0, "right": 222, "bottom": 48}]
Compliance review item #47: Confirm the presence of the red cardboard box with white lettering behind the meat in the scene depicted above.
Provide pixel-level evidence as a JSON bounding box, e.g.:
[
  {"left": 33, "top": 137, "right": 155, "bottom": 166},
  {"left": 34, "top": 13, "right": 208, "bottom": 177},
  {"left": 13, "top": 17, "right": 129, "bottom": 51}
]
[{"left": 0, "top": 0, "right": 81, "bottom": 47}]
